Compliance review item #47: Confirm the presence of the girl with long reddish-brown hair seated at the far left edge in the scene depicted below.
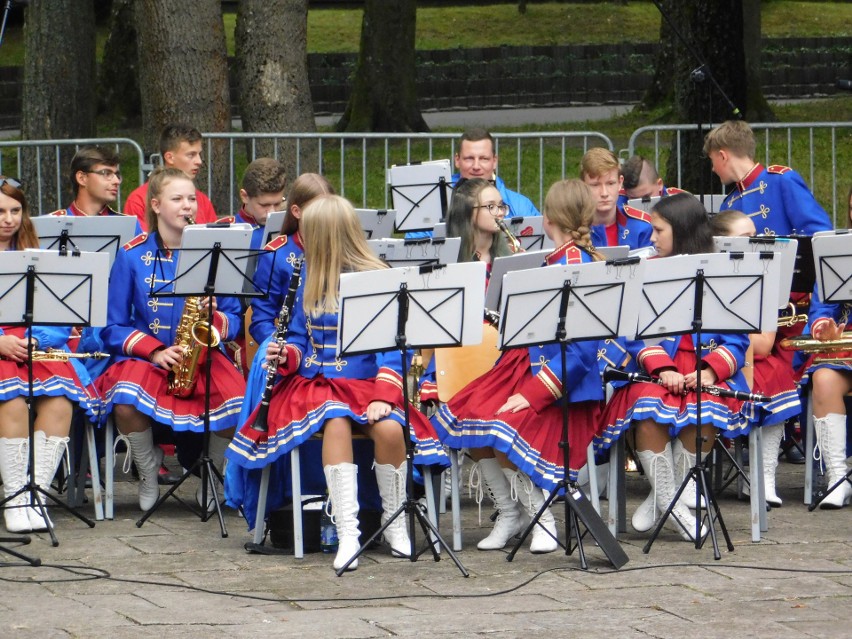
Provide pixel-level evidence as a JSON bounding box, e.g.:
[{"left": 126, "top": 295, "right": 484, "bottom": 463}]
[{"left": 0, "top": 176, "right": 99, "bottom": 533}]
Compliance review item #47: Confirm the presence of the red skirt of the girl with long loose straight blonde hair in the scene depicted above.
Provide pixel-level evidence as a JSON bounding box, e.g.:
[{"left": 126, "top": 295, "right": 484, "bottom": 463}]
[{"left": 226, "top": 375, "right": 449, "bottom": 468}]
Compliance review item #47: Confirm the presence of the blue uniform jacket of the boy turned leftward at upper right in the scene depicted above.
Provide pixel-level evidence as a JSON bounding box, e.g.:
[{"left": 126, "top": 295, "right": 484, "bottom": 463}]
[{"left": 721, "top": 163, "right": 833, "bottom": 235}]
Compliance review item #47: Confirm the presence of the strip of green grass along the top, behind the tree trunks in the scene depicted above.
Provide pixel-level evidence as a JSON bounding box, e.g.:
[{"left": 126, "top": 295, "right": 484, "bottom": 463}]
[{"left": 0, "top": 0, "right": 852, "bottom": 66}]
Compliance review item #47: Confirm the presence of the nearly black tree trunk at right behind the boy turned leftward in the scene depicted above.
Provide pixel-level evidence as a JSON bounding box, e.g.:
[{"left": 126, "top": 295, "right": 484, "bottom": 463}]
[{"left": 666, "top": 0, "right": 776, "bottom": 193}]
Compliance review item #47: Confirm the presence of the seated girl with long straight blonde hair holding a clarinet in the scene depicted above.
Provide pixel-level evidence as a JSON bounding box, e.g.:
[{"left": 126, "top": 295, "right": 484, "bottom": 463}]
[{"left": 226, "top": 195, "right": 445, "bottom": 570}]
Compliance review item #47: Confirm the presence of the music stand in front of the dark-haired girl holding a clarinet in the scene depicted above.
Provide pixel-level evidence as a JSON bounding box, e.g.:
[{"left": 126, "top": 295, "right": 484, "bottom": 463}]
[{"left": 636, "top": 252, "right": 781, "bottom": 560}]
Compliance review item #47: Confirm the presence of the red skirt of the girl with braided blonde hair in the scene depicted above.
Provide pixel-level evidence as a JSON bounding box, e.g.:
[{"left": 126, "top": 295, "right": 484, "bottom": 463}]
[{"left": 432, "top": 348, "right": 600, "bottom": 490}]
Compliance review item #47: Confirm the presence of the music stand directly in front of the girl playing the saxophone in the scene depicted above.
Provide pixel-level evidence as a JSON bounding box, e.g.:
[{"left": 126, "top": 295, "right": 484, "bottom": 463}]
[{"left": 136, "top": 223, "right": 264, "bottom": 538}]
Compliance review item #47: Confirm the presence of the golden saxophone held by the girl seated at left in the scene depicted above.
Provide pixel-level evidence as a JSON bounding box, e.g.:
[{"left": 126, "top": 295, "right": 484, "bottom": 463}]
[{"left": 166, "top": 296, "right": 222, "bottom": 397}]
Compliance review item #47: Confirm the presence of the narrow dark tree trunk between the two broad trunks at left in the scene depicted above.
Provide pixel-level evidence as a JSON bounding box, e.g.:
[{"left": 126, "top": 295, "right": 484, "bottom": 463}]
[{"left": 98, "top": 0, "right": 142, "bottom": 127}]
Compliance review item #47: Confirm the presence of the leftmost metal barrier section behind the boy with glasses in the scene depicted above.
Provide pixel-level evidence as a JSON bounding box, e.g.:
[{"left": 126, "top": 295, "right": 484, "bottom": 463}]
[{"left": 0, "top": 138, "right": 150, "bottom": 215}]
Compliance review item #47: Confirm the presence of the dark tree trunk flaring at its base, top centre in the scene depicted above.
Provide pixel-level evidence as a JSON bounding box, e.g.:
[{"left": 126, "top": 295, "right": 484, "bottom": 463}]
[{"left": 337, "top": 0, "right": 429, "bottom": 131}]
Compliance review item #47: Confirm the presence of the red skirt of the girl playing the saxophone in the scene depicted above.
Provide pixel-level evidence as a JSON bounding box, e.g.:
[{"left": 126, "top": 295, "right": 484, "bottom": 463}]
[{"left": 95, "top": 351, "right": 245, "bottom": 432}]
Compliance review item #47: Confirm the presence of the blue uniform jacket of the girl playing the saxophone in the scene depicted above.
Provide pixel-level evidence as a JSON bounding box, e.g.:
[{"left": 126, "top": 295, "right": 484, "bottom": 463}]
[{"left": 101, "top": 233, "right": 240, "bottom": 359}]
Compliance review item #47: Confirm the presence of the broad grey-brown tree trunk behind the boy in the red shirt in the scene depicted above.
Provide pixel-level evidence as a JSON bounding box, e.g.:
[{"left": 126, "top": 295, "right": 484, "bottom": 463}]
[{"left": 135, "top": 0, "right": 231, "bottom": 210}]
